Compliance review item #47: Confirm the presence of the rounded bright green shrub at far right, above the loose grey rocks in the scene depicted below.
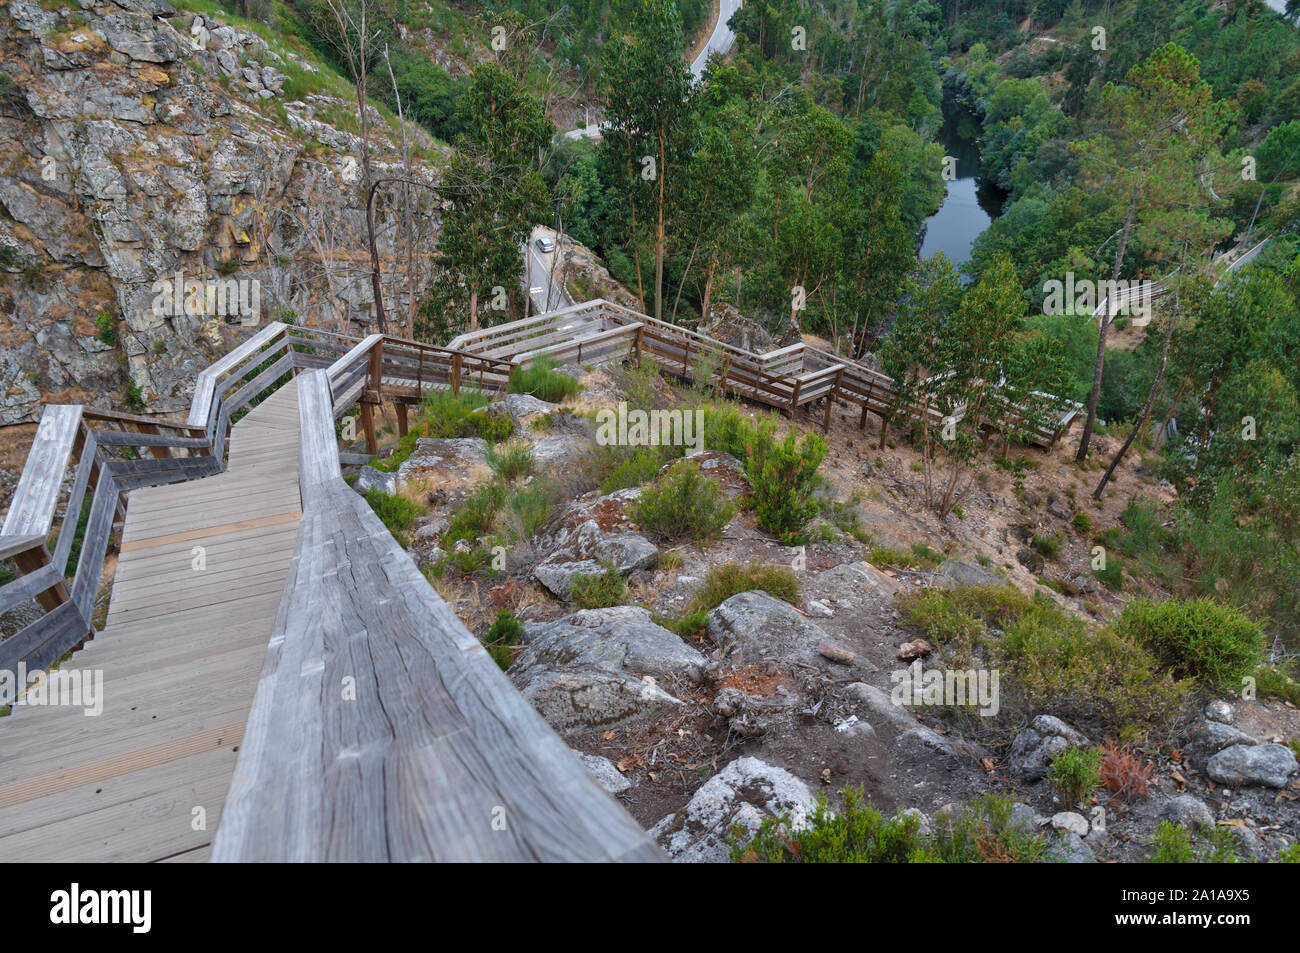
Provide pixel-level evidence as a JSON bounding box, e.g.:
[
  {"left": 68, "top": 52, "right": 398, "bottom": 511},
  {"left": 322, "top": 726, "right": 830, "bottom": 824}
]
[{"left": 1114, "top": 599, "right": 1265, "bottom": 692}]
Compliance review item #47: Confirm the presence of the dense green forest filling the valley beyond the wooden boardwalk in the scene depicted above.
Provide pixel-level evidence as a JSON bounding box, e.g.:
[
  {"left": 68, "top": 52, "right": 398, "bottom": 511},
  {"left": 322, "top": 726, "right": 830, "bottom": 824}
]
[{"left": 263, "top": 0, "right": 1300, "bottom": 660}]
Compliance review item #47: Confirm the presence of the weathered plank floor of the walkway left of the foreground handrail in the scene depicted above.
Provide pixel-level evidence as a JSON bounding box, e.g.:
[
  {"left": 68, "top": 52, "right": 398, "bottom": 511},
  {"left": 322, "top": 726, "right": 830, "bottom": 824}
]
[{"left": 0, "top": 385, "right": 302, "bottom": 862}]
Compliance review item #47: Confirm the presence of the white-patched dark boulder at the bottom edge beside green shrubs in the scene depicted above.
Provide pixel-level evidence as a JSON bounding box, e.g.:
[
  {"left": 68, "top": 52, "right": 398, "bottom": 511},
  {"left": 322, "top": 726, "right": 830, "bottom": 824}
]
[{"left": 650, "top": 758, "right": 814, "bottom": 863}]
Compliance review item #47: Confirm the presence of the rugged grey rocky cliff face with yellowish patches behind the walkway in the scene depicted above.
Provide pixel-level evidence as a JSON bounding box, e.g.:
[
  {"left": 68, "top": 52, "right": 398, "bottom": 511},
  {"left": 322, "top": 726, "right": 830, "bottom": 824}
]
[{"left": 0, "top": 0, "right": 437, "bottom": 424}]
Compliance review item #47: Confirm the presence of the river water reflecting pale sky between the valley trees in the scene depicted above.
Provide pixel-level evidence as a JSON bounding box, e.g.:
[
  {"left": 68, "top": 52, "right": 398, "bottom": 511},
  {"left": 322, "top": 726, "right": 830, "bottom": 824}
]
[{"left": 919, "top": 100, "right": 1006, "bottom": 275}]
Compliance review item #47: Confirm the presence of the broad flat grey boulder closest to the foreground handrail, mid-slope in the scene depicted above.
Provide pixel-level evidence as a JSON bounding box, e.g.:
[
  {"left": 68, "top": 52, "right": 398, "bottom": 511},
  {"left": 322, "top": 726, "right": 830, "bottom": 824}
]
[{"left": 510, "top": 606, "right": 705, "bottom": 733}]
